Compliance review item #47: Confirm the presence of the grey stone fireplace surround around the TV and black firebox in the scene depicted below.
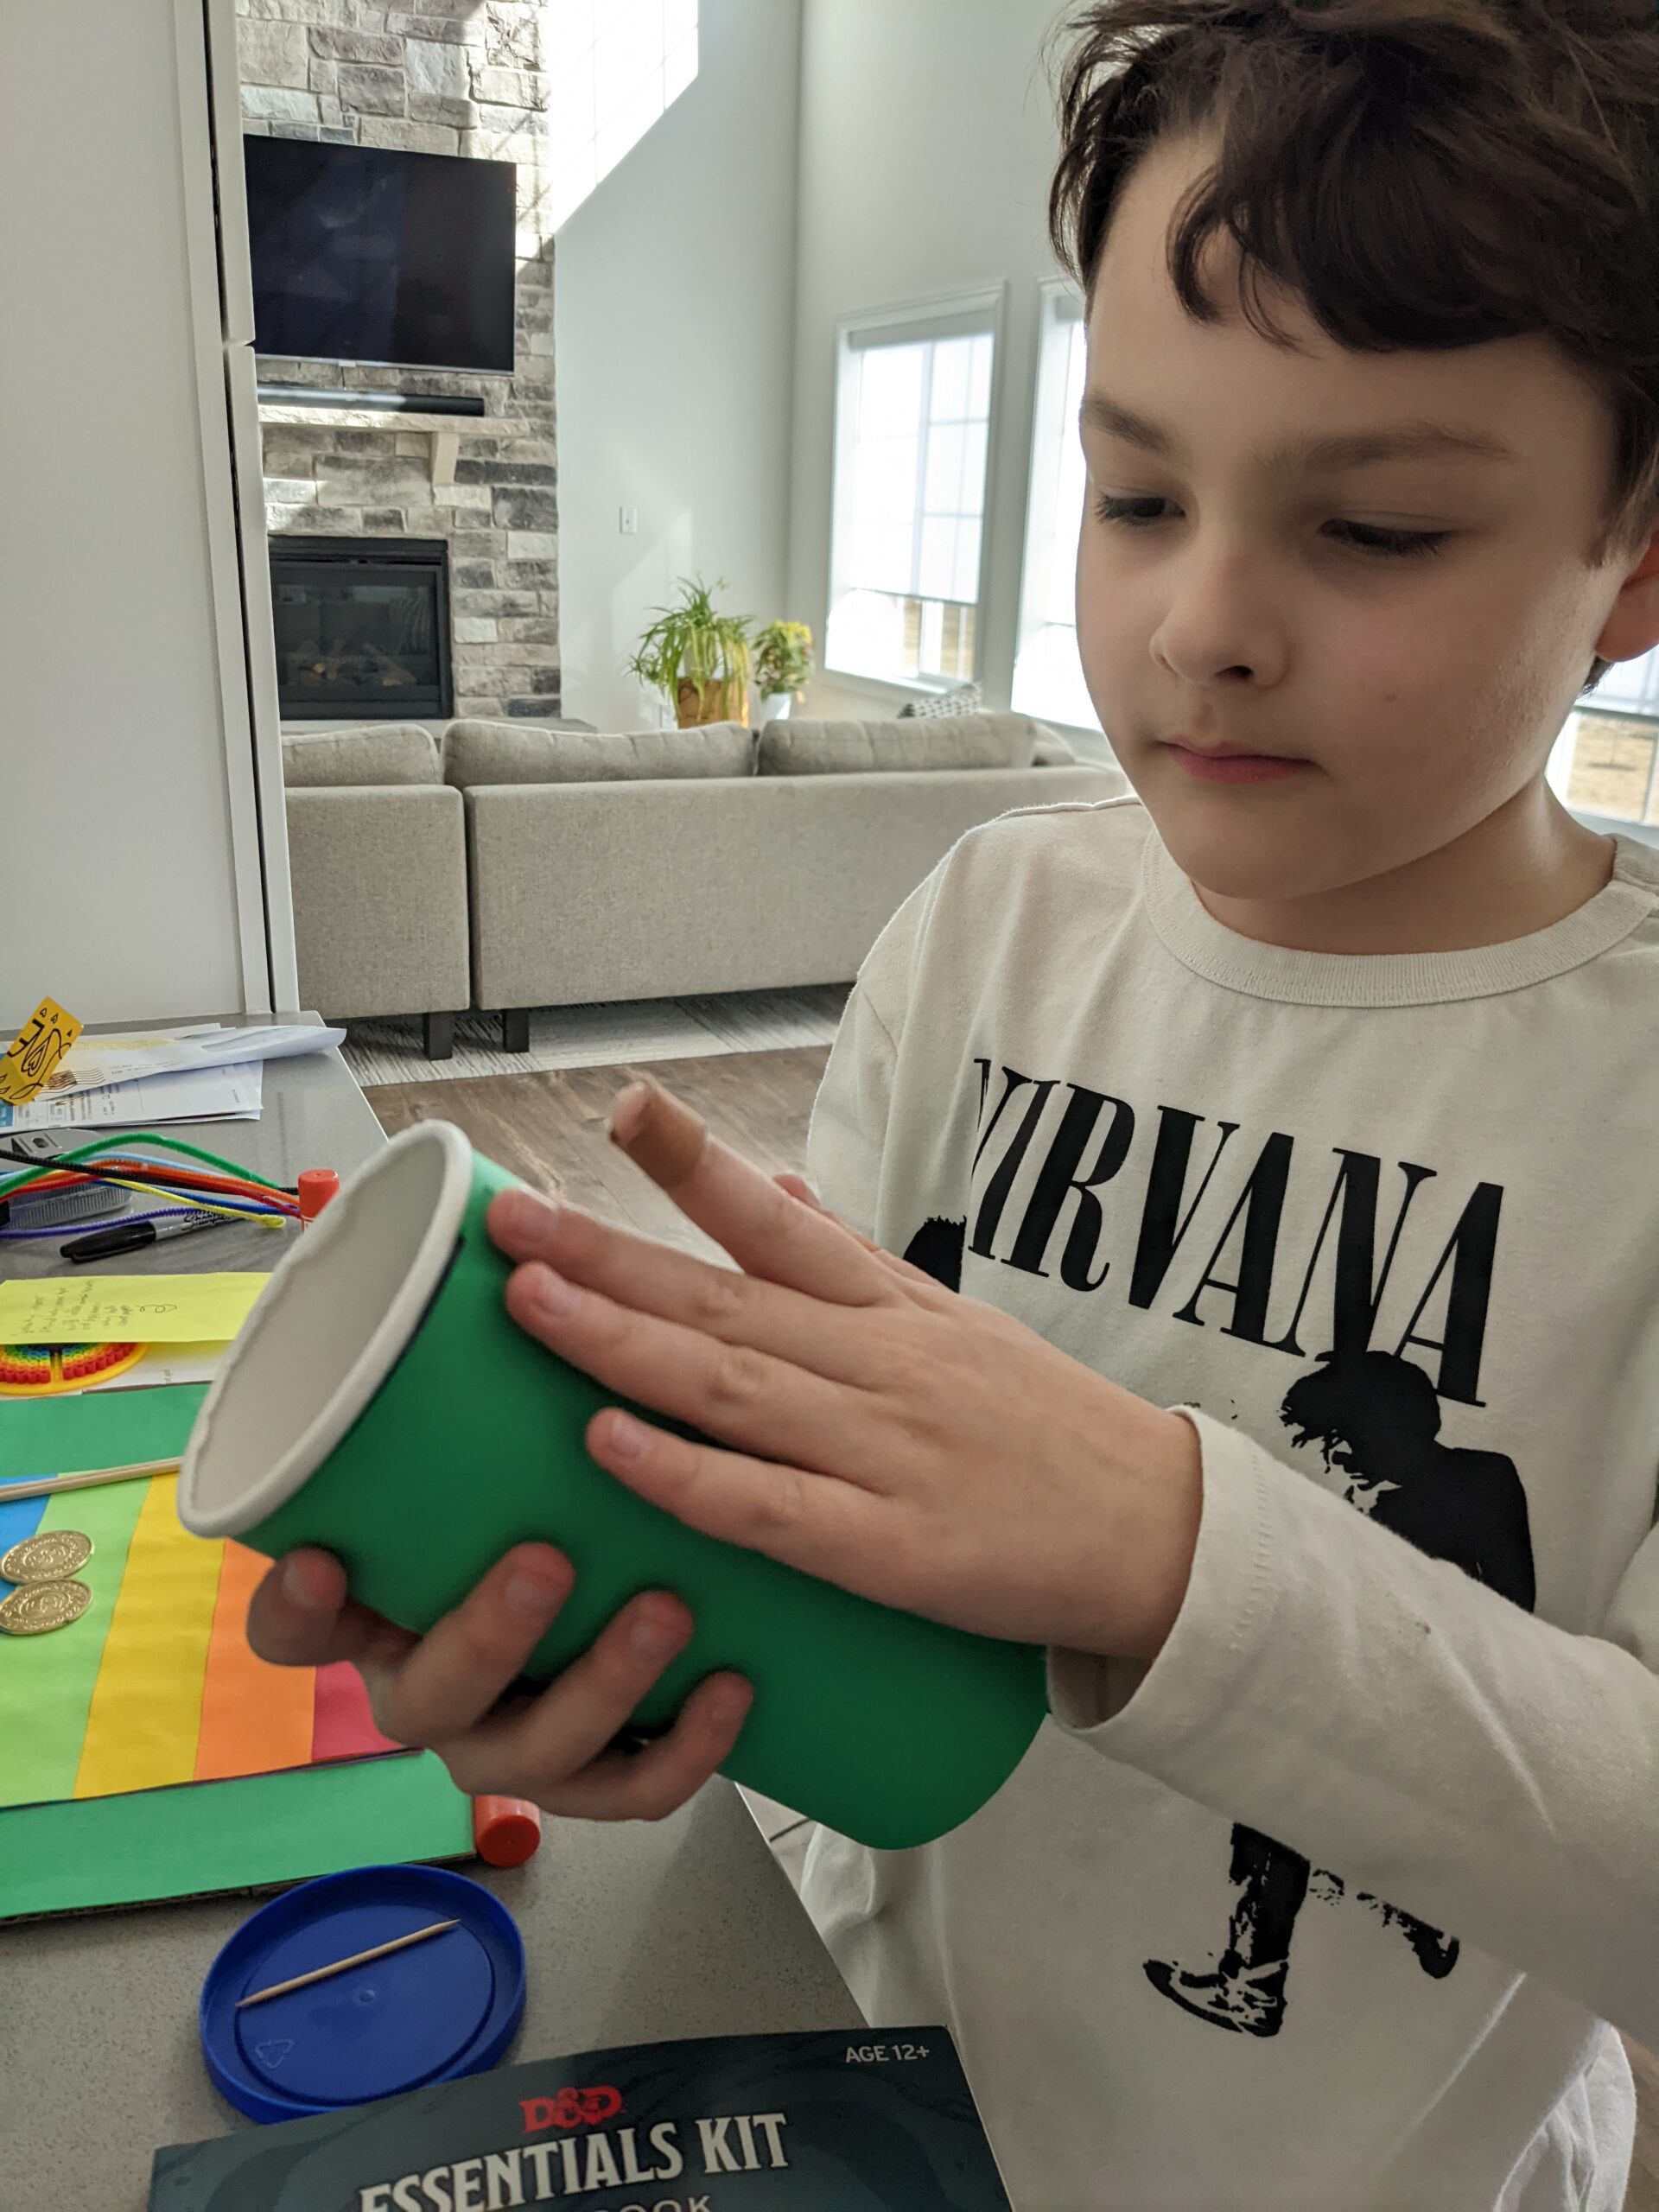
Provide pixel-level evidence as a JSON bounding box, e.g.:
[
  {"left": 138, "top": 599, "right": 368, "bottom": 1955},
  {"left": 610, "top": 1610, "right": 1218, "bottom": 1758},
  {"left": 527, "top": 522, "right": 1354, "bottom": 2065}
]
[{"left": 237, "top": 0, "right": 560, "bottom": 719}]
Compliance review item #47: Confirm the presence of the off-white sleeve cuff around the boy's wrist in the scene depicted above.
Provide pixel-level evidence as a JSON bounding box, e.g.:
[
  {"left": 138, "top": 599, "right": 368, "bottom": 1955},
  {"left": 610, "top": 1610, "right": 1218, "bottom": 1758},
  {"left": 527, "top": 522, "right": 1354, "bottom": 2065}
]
[{"left": 1048, "top": 1405, "right": 1272, "bottom": 1765}]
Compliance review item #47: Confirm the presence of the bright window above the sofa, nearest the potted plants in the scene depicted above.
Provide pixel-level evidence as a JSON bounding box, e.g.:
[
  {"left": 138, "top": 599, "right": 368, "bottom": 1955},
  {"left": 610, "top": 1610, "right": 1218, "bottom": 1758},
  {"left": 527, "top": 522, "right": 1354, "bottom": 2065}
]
[{"left": 825, "top": 294, "right": 1002, "bottom": 683}]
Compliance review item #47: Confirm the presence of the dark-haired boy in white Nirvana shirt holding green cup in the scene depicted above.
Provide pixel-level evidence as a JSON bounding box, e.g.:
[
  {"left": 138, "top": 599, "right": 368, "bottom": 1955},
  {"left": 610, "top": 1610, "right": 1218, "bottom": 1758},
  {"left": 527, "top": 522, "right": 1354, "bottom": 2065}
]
[{"left": 254, "top": 0, "right": 1659, "bottom": 2212}]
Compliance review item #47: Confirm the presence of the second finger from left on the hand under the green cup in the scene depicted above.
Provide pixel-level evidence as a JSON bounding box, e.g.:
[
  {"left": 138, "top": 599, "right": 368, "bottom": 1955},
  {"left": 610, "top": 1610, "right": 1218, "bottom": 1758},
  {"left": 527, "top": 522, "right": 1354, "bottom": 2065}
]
[{"left": 359, "top": 1544, "right": 575, "bottom": 1745}]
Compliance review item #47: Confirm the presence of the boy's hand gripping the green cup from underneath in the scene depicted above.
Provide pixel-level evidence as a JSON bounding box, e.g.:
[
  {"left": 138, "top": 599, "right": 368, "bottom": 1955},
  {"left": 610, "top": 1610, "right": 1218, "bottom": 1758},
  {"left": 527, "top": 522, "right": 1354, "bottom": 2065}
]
[{"left": 248, "top": 1544, "right": 750, "bottom": 1821}]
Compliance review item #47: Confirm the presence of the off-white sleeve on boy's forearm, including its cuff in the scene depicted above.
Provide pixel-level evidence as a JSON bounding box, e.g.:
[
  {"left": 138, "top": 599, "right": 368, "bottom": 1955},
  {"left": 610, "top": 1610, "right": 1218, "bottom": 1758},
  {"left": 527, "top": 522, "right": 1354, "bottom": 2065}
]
[{"left": 1051, "top": 1418, "right": 1659, "bottom": 2042}]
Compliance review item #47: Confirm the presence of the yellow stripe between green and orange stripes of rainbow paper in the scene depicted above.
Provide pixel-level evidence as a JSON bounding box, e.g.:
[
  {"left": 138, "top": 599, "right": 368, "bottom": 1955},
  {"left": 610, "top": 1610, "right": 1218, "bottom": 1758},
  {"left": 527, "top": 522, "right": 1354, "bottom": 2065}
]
[{"left": 75, "top": 1476, "right": 226, "bottom": 1798}]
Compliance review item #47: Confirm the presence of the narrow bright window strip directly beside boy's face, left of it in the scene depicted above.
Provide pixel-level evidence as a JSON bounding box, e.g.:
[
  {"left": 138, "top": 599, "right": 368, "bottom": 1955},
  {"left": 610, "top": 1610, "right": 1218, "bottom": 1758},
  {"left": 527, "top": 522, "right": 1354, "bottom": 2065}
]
[{"left": 1013, "top": 279, "right": 1099, "bottom": 730}]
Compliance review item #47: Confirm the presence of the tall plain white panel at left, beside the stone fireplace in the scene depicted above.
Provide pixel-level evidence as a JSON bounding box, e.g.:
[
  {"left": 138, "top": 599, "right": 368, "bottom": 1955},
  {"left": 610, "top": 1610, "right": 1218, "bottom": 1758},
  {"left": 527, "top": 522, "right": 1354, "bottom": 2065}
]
[{"left": 0, "top": 0, "right": 268, "bottom": 1038}]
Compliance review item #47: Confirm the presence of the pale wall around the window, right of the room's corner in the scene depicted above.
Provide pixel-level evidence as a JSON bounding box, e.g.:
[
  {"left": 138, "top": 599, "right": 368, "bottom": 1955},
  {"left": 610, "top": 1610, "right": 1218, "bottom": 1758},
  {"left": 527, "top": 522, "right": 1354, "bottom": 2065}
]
[{"left": 787, "top": 0, "right": 1106, "bottom": 743}]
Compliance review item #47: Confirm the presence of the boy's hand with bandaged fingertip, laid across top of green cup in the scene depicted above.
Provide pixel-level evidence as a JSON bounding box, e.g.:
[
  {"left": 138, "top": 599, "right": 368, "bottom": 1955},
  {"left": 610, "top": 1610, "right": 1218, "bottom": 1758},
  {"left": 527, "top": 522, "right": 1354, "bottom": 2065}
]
[{"left": 489, "top": 1084, "right": 1201, "bottom": 1663}]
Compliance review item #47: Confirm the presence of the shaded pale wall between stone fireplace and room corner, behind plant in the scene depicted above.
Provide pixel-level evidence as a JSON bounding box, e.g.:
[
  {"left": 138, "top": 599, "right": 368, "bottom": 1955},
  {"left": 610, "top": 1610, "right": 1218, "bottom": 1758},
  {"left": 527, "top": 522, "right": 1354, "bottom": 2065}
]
[{"left": 553, "top": 0, "right": 801, "bottom": 730}]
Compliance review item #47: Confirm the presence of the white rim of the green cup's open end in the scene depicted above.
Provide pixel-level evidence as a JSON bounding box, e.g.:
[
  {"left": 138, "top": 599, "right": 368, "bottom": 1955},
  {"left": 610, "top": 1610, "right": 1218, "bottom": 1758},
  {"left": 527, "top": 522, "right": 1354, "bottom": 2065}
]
[{"left": 177, "top": 1122, "right": 474, "bottom": 1537}]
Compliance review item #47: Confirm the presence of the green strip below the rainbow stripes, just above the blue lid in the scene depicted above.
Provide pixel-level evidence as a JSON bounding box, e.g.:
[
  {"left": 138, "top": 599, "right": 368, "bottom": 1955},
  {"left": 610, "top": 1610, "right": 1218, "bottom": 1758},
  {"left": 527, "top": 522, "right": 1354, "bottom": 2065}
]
[{"left": 0, "top": 1752, "right": 474, "bottom": 1920}]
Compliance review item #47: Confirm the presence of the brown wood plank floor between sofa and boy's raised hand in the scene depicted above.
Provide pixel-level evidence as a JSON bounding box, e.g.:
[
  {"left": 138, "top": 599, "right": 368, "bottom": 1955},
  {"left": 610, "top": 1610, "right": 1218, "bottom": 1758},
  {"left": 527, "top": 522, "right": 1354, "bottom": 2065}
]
[{"left": 365, "top": 1044, "right": 1659, "bottom": 2212}]
